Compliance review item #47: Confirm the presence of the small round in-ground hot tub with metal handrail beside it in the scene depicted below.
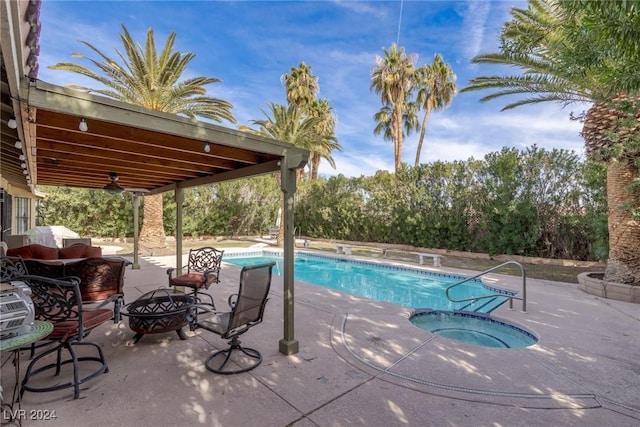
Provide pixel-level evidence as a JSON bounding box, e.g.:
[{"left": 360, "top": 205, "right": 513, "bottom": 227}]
[{"left": 409, "top": 309, "right": 538, "bottom": 348}]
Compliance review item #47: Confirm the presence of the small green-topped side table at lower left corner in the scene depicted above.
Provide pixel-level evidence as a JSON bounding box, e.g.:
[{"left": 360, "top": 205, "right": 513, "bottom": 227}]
[{"left": 0, "top": 320, "right": 53, "bottom": 425}]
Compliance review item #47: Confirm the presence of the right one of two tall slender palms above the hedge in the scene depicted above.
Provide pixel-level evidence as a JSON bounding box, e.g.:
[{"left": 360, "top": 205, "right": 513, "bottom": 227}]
[{"left": 415, "top": 53, "right": 458, "bottom": 166}]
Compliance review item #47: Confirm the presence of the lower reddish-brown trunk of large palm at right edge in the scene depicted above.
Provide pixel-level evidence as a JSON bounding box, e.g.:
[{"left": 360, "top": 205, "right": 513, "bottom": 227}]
[{"left": 604, "top": 160, "right": 640, "bottom": 286}]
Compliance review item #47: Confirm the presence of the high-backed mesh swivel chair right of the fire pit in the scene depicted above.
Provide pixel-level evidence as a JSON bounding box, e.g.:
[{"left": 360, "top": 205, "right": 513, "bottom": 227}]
[{"left": 189, "top": 262, "right": 275, "bottom": 375}]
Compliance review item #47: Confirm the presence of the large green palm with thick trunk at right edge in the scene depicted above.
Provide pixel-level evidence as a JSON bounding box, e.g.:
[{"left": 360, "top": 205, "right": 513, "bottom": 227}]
[{"left": 462, "top": 0, "right": 640, "bottom": 285}]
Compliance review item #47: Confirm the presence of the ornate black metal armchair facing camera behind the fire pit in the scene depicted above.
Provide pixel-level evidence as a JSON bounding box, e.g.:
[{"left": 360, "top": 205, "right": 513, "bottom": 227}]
[{"left": 167, "top": 247, "right": 224, "bottom": 309}]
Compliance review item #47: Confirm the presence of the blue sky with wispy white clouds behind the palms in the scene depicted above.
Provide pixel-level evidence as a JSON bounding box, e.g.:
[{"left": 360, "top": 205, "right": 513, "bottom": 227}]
[{"left": 38, "top": 0, "right": 586, "bottom": 176}]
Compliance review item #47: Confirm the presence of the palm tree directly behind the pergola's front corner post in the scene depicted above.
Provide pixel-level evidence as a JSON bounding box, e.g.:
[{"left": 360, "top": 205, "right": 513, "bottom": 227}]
[{"left": 251, "top": 104, "right": 320, "bottom": 246}]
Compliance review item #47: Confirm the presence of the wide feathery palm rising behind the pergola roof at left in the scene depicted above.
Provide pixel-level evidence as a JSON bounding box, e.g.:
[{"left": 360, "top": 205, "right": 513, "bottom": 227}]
[{"left": 49, "top": 25, "right": 236, "bottom": 255}]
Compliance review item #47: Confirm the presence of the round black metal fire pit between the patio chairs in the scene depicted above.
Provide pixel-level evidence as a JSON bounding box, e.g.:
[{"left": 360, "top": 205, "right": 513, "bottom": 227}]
[{"left": 122, "top": 288, "right": 196, "bottom": 343}]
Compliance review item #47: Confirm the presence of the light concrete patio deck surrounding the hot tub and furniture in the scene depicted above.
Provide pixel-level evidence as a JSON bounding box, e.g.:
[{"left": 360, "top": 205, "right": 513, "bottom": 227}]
[{"left": 2, "top": 251, "right": 640, "bottom": 427}]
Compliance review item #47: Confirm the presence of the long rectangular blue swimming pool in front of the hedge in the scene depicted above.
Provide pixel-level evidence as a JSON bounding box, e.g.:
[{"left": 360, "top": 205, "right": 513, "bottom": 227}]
[{"left": 223, "top": 253, "right": 507, "bottom": 313}]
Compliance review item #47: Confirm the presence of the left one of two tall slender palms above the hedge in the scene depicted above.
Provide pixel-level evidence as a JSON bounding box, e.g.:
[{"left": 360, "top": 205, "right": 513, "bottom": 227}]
[{"left": 371, "top": 43, "right": 417, "bottom": 173}]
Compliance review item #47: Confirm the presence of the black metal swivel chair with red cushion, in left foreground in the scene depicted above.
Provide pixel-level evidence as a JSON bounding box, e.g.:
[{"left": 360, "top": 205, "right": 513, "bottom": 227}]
[{"left": 20, "top": 276, "right": 113, "bottom": 399}]
